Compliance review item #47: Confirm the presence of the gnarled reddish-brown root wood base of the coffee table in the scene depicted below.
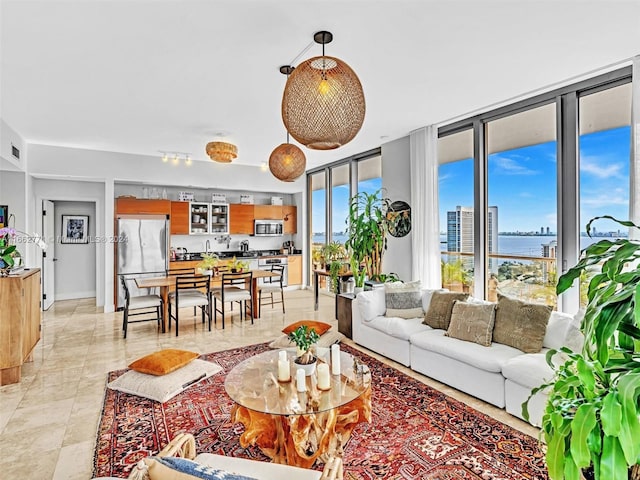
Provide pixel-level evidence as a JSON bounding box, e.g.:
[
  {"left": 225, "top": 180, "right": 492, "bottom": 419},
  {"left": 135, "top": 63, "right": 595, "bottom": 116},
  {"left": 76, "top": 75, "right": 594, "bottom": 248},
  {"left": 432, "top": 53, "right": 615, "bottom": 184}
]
[{"left": 231, "top": 387, "right": 371, "bottom": 468}]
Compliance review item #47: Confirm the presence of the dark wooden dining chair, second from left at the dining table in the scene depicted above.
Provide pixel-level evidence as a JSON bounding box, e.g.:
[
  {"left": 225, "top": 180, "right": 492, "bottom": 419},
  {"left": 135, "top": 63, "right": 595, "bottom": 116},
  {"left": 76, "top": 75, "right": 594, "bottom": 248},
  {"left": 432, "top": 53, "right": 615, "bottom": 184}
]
[{"left": 169, "top": 275, "right": 211, "bottom": 337}]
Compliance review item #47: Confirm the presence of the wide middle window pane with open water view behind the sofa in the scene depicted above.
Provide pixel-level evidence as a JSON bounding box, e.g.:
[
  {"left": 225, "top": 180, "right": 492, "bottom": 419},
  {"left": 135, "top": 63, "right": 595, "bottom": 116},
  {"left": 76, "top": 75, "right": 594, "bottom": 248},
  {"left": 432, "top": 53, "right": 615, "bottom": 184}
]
[{"left": 485, "top": 102, "right": 558, "bottom": 305}]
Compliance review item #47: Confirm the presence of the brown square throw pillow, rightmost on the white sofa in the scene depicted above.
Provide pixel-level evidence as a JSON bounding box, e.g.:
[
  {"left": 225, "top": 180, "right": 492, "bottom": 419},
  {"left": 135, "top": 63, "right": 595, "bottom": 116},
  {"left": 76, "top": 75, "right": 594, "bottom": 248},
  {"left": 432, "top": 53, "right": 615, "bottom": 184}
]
[{"left": 493, "top": 293, "right": 553, "bottom": 353}]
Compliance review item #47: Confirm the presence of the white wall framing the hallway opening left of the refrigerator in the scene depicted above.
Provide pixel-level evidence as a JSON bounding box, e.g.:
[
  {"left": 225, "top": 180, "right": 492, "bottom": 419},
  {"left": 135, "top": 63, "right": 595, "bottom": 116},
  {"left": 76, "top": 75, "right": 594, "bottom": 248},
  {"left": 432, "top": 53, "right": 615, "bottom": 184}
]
[{"left": 33, "top": 178, "right": 105, "bottom": 311}]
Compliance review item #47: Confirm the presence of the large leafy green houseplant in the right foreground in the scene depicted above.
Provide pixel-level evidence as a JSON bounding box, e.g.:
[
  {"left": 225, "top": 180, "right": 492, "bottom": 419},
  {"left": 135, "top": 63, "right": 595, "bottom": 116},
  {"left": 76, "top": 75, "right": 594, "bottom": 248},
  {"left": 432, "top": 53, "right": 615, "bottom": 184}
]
[{"left": 523, "top": 216, "right": 640, "bottom": 480}]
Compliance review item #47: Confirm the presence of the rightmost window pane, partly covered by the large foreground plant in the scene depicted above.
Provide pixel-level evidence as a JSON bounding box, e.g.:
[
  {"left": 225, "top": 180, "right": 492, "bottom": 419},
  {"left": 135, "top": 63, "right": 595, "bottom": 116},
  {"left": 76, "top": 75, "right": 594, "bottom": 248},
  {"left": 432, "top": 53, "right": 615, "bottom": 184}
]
[{"left": 578, "top": 83, "right": 631, "bottom": 305}]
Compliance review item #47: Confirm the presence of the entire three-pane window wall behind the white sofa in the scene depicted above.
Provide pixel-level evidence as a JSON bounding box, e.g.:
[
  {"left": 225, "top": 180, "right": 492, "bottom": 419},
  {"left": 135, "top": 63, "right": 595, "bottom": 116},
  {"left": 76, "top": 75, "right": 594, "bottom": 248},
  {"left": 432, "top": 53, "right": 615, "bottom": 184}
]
[{"left": 439, "top": 67, "right": 631, "bottom": 312}]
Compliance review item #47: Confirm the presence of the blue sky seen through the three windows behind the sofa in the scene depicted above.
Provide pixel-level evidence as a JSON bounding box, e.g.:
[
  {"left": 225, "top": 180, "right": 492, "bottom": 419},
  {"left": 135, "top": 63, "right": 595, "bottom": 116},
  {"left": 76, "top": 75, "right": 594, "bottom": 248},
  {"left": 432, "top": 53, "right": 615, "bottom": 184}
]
[{"left": 439, "top": 126, "right": 630, "bottom": 232}]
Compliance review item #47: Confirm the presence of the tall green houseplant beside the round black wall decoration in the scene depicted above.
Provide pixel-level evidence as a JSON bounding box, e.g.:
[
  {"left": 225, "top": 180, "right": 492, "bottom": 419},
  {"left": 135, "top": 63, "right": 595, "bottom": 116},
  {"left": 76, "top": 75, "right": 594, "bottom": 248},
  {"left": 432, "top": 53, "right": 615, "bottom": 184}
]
[{"left": 345, "top": 189, "right": 391, "bottom": 287}]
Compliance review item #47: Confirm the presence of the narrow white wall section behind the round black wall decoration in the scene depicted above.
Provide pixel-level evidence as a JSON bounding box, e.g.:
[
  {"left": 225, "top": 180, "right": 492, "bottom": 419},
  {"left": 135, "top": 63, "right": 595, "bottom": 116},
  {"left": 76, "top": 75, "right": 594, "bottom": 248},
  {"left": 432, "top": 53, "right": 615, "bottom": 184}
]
[{"left": 382, "top": 137, "right": 412, "bottom": 281}]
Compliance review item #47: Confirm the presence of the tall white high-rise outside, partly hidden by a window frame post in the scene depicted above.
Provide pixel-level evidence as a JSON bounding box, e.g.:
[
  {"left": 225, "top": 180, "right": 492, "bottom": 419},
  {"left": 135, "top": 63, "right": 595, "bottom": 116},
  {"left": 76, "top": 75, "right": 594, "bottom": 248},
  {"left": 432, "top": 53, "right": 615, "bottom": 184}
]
[{"left": 447, "top": 205, "right": 498, "bottom": 271}]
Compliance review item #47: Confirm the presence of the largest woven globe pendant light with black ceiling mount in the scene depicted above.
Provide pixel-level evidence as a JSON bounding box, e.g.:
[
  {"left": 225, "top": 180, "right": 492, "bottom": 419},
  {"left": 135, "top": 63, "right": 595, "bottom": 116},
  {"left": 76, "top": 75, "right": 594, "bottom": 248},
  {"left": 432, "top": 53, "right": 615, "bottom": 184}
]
[{"left": 282, "top": 32, "right": 366, "bottom": 150}]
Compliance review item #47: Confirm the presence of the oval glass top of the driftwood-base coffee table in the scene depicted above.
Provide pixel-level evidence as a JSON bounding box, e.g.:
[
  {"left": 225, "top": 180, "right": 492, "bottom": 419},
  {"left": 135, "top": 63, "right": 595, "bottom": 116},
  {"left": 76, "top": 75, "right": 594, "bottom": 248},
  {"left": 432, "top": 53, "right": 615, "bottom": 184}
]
[{"left": 224, "top": 349, "right": 371, "bottom": 415}]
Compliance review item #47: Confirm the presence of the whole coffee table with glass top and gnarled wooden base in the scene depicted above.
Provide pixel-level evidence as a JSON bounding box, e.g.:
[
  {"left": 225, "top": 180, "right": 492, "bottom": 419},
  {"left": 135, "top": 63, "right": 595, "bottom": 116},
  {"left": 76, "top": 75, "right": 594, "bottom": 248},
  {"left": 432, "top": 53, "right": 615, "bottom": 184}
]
[{"left": 224, "top": 350, "right": 371, "bottom": 468}]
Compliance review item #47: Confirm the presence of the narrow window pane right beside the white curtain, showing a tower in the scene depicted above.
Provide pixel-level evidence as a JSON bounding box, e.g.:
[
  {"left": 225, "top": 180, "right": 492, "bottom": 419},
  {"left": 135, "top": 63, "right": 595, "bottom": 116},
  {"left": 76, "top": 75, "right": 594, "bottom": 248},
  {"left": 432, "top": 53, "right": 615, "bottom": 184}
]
[{"left": 438, "top": 129, "right": 474, "bottom": 292}]
